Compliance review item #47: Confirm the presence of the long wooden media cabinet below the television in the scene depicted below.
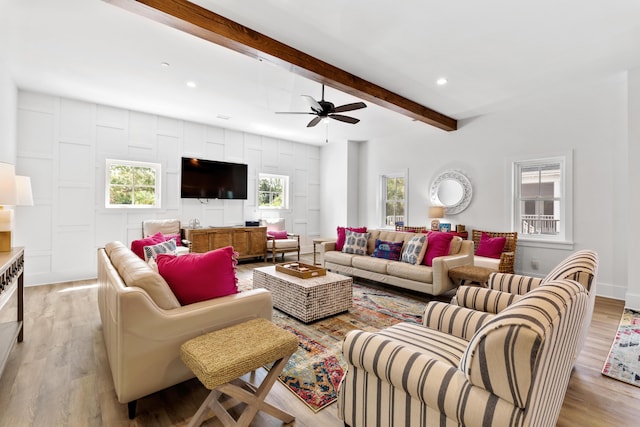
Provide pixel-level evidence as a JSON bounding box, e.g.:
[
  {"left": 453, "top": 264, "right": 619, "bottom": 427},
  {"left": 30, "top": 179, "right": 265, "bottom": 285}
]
[{"left": 182, "top": 227, "right": 267, "bottom": 261}]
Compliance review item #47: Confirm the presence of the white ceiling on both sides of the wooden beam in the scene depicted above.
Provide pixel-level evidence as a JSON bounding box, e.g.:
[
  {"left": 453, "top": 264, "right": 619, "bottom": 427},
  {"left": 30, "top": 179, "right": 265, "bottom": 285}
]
[{"left": 0, "top": 0, "right": 640, "bottom": 144}]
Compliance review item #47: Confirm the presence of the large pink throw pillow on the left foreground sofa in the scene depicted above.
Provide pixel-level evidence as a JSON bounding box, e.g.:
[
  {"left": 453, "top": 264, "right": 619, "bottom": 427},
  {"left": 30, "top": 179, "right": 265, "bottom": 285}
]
[{"left": 156, "top": 246, "right": 238, "bottom": 305}]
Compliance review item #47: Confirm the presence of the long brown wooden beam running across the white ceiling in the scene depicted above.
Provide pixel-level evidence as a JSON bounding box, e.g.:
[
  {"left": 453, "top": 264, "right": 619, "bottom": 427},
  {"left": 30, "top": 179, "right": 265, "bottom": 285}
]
[{"left": 104, "top": 0, "right": 458, "bottom": 131}]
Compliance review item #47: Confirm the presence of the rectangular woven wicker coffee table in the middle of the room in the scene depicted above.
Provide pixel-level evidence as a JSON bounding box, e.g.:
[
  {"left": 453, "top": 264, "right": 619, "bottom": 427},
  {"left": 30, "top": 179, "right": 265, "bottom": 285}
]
[{"left": 253, "top": 266, "right": 353, "bottom": 323}]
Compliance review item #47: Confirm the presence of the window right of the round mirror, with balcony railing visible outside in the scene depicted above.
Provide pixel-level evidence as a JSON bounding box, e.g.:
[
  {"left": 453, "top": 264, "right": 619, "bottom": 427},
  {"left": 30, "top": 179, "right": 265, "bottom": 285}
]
[{"left": 513, "top": 156, "right": 571, "bottom": 241}]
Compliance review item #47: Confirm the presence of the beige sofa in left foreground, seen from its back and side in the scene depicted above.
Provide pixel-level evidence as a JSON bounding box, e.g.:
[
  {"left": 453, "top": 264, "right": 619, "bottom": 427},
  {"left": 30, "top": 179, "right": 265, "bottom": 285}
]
[{"left": 98, "top": 242, "right": 272, "bottom": 418}]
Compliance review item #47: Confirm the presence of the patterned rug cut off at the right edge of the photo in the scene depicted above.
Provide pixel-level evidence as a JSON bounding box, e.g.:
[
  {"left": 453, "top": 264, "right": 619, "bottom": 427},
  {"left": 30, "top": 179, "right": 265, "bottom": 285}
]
[{"left": 602, "top": 308, "right": 640, "bottom": 387}]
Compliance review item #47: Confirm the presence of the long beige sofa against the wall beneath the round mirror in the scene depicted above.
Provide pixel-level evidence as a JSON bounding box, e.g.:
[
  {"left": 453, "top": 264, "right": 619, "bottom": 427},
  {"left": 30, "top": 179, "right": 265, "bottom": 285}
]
[{"left": 320, "top": 230, "right": 473, "bottom": 295}]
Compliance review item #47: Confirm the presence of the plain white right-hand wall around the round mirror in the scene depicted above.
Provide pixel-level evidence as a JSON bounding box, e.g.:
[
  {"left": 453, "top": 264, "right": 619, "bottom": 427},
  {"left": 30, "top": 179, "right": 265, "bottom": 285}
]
[{"left": 350, "top": 73, "right": 624, "bottom": 299}]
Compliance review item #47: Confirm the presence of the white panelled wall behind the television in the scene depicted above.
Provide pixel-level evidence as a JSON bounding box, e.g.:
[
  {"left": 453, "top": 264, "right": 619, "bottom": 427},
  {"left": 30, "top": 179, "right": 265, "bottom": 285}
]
[{"left": 14, "top": 91, "right": 320, "bottom": 285}]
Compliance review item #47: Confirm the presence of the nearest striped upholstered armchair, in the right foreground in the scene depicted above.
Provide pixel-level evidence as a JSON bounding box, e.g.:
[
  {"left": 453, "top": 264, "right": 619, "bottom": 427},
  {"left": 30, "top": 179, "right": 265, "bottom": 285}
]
[{"left": 338, "top": 280, "right": 589, "bottom": 427}]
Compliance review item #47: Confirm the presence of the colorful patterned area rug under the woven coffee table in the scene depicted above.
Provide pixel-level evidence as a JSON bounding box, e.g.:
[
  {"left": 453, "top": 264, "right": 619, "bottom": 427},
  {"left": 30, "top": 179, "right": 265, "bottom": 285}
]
[{"left": 240, "top": 283, "right": 426, "bottom": 412}]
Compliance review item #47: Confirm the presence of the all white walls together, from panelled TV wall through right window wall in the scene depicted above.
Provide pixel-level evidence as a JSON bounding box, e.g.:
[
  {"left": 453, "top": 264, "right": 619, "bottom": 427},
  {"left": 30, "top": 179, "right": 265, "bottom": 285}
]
[{"left": 10, "top": 70, "right": 640, "bottom": 306}]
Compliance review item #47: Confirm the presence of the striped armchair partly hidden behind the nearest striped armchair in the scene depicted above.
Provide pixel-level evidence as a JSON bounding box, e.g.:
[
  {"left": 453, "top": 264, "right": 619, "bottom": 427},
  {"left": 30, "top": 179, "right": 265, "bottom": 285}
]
[{"left": 451, "top": 250, "right": 598, "bottom": 357}]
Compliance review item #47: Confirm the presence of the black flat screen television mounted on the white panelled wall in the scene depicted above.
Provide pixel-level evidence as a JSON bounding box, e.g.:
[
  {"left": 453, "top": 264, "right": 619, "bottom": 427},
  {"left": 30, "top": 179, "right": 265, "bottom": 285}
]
[{"left": 180, "top": 157, "right": 247, "bottom": 200}]
